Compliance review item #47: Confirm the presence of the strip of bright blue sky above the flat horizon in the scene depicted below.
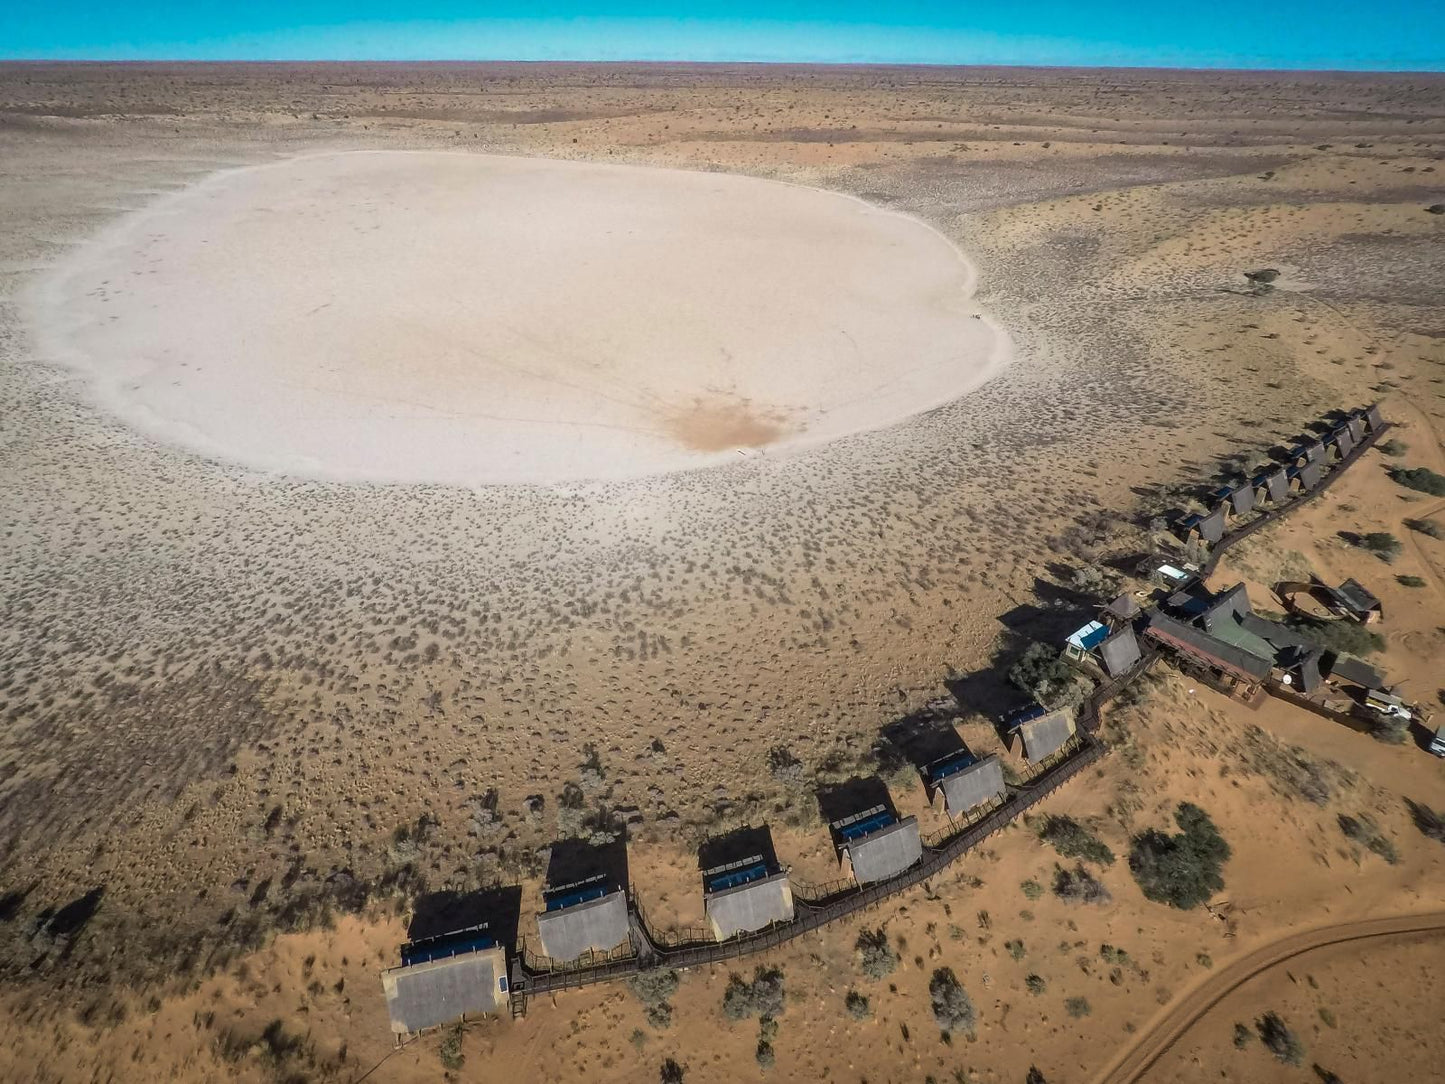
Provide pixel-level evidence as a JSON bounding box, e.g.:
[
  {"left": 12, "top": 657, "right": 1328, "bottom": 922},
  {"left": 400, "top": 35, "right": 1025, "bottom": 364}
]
[{"left": 0, "top": 0, "right": 1445, "bottom": 71}]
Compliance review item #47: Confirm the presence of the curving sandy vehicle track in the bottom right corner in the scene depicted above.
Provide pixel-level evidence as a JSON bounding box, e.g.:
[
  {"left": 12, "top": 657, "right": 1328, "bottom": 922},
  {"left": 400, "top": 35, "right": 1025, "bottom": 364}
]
[{"left": 1094, "top": 912, "right": 1445, "bottom": 1084}]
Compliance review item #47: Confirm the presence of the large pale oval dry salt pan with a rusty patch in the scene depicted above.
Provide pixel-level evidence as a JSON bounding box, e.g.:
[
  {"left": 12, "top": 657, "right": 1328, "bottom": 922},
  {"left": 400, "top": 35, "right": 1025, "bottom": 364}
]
[{"left": 38, "top": 152, "right": 1001, "bottom": 486}]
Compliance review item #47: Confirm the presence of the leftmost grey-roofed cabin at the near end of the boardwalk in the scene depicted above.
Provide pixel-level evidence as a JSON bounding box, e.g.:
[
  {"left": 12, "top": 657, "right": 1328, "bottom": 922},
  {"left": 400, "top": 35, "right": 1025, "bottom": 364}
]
[{"left": 381, "top": 926, "right": 507, "bottom": 1035}]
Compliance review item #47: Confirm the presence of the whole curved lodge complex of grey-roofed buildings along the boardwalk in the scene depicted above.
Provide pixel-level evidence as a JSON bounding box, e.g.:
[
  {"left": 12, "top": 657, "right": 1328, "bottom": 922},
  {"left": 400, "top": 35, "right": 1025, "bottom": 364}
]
[{"left": 381, "top": 406, "right": 1398, "bottom": 1036}]
